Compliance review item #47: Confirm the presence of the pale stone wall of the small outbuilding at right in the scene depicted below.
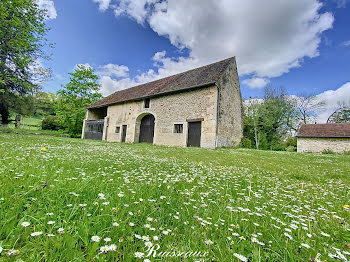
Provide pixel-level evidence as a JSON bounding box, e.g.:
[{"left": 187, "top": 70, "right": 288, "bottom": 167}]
[{"left": 298, "top": 137, "right": 350, "bottom": 153}]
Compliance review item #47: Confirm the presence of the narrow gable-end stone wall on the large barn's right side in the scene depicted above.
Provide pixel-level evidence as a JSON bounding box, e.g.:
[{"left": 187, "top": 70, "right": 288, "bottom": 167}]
[{"left": 217, "top": 58, "right": 243, "bottom": 147}]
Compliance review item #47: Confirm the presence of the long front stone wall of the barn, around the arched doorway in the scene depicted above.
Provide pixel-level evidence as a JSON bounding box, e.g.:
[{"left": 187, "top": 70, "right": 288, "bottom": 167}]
[{"left": 100, "top": 86, "right": 217, "bottom": 148}]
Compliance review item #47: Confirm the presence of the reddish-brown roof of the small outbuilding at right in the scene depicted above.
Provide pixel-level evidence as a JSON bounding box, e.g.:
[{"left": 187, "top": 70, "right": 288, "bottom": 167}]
[{"left": 297, "top": 123, "right": 350, "bottom": 138}]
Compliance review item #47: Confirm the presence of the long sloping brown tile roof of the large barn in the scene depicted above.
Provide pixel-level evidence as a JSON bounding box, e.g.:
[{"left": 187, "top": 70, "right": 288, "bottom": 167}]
[{"left": 88, "top": 57, "right": 235, "bottom": 108}]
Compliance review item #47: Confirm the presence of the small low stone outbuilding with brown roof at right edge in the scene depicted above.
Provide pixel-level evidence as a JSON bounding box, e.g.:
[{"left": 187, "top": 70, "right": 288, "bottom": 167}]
[{"left": 297, "top": 123, "right": 350, "bottom": 153}]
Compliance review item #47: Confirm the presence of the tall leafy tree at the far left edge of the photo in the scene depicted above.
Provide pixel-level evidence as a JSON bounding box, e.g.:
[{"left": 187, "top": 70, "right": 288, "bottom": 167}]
[{"left": 0, "top": 0, "right": 49, "bottom": 125}]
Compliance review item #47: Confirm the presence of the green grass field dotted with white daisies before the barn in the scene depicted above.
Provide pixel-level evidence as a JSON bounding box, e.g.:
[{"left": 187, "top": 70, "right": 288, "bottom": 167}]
[{"left": 0, "top": 133, "right": 350, "bottom": 261}]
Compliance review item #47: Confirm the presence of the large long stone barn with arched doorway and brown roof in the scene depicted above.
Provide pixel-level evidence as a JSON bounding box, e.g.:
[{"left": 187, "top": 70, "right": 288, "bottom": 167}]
[{"left": 82, "top": 57, "right": 242, "bottom": 148}]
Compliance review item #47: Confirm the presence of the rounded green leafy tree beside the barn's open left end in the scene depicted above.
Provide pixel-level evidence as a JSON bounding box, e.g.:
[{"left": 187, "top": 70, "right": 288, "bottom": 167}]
[{"left": 56, "top": 65, "right": 102, "bottom": 137}]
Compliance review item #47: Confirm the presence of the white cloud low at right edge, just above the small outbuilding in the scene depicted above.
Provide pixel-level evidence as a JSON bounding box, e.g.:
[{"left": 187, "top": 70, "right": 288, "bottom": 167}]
[{"left": 316, "top": 82, "right": 350, "bottom": 123}]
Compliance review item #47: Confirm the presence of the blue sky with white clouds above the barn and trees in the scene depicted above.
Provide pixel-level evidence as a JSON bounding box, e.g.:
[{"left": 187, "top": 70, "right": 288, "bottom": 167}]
[{"left": 36, "top": 0, "right": 350, "bottom": 122}]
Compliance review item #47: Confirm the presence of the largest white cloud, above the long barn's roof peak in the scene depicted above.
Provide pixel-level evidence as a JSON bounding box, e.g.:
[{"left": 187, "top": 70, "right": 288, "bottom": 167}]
[{"left": 107, "top": 0, "right": 334, "bottom": 81}]
